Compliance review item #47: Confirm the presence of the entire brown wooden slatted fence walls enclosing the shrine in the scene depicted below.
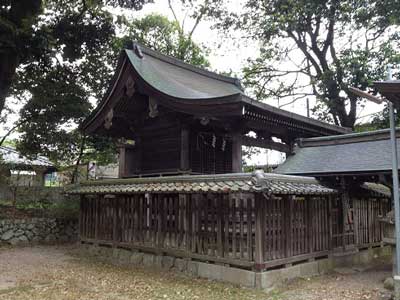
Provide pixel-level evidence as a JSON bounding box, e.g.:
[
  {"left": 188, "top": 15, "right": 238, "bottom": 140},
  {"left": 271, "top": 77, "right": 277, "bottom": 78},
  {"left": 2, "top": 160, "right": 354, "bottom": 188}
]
[{"left": 80, "top": 193, "right": 390, "bottom": 265}]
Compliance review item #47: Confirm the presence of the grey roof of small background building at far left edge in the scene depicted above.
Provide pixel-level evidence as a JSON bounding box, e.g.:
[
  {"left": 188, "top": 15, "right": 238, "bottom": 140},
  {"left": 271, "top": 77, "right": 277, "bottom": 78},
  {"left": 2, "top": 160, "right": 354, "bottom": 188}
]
[{"left": 0, "top": 146, "right": 54, "bottom": 168}]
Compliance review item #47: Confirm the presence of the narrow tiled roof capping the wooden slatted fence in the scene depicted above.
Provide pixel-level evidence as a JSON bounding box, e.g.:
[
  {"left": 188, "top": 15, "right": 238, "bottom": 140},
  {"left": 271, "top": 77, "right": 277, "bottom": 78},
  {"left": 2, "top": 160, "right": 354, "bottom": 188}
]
[{"left": 67, "top": 171, "right": 337, "bottom": 195}]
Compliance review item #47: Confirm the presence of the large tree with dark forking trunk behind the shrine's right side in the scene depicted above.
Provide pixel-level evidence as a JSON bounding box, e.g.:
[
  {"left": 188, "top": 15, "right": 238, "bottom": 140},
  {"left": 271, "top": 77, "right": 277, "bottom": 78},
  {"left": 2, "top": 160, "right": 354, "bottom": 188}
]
[{"left": 225, "top": 0, "right": 400, "bottom": 128}]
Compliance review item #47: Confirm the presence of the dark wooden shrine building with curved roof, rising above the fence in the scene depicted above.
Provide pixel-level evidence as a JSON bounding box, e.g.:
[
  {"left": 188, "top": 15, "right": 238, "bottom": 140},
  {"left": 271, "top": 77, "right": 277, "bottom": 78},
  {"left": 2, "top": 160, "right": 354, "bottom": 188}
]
[{"left": 82, "top": 43, "right": 349, "bottom": 177}]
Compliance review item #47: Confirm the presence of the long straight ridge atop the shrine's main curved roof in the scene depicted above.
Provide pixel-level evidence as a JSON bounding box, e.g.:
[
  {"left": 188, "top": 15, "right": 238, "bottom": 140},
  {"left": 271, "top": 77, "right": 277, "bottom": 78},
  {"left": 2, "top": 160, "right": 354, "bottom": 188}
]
[{"left": 127, "top": 41, "right": 243, "bottom": 91}]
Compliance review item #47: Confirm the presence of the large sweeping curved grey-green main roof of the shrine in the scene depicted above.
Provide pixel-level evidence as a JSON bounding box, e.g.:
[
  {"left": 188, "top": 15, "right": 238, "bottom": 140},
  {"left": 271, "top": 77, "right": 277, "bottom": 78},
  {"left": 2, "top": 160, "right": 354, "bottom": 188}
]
[{"left": 81, "top": 43, "right": 351, "bottom": 137}]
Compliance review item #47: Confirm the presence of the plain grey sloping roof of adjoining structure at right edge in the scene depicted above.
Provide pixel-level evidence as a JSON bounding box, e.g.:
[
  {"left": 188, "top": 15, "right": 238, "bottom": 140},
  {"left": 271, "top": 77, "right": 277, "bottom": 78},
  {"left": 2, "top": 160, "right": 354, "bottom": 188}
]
[{"left": 275, "top": 129, "right": 400, "bottom": 176}]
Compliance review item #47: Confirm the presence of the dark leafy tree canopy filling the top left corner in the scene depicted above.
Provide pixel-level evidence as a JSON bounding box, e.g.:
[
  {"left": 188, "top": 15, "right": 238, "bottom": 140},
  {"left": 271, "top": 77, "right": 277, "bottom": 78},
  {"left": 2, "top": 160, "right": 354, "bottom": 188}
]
[{"left": 0, "top": 0, "right": 151, "bottom": 113}]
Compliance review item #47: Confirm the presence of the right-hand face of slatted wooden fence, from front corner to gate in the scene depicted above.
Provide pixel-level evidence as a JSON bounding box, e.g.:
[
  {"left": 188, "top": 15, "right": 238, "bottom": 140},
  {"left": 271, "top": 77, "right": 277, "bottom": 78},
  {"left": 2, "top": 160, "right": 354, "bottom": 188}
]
[{"left": 264, "top": 196, "right": 330, "bottom": 261}]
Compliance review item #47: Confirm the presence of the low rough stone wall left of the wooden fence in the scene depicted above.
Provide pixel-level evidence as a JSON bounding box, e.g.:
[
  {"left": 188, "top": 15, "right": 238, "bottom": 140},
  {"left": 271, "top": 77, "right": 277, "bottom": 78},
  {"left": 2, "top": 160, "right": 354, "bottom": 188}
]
[{"left": 0, "top": 218, "right": 78, "bottom": 245}]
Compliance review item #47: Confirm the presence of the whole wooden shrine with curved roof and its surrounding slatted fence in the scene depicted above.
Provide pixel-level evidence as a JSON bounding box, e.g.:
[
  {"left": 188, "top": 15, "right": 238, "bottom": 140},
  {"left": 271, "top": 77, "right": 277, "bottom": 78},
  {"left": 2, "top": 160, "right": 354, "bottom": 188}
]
[{"left": 67, "top": 43, "right": 391, "bottom": 287}]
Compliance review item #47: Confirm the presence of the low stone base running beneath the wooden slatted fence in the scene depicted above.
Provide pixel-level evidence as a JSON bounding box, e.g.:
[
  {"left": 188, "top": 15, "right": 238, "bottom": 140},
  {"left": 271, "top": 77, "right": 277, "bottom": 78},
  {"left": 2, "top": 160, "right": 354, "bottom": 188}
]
[{"left": 82, "top": 244, "right": 392, "bottom": 290}]
